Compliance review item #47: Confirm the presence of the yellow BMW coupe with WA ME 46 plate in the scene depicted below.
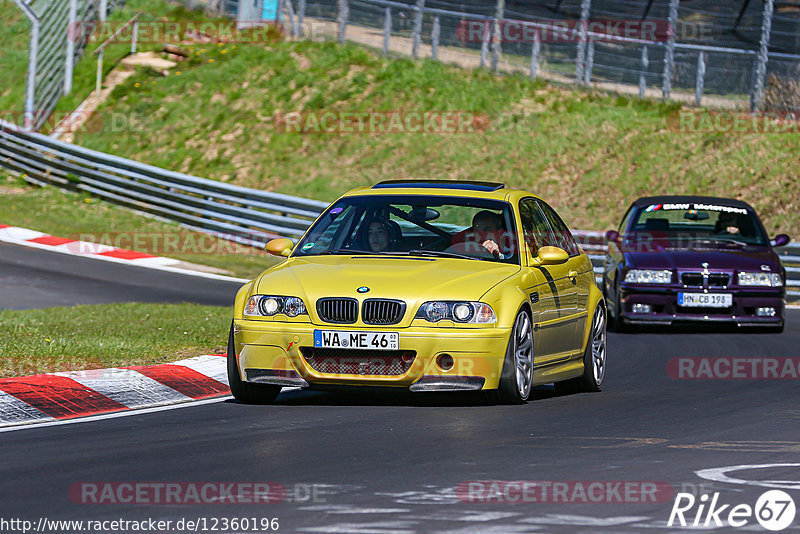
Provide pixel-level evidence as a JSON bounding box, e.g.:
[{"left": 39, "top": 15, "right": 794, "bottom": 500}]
[{"left": 228, "top": 180, "right": 606, "bottom": 403}]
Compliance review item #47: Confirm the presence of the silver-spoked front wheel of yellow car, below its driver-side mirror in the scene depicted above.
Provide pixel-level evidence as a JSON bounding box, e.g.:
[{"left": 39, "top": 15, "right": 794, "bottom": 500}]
[{"left": 495, "top": 310, "right": 533, "bottom": 404}]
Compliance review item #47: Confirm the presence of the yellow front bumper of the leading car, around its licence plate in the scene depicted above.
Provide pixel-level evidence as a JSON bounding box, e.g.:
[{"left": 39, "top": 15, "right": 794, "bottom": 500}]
[{"left": 234, "top": 319, "right": 511, "bottom": 391}]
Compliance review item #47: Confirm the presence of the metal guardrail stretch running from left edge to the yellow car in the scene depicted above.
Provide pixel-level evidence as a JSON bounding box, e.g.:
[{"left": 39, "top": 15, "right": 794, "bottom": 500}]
[{"left": 0, "top": 120, "right": 328, "bottom": 245}]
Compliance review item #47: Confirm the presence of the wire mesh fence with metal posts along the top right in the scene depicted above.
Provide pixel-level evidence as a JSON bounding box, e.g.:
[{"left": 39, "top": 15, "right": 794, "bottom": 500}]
[{"left": 293, "top": 0, "right": 800, "bottom": 109}]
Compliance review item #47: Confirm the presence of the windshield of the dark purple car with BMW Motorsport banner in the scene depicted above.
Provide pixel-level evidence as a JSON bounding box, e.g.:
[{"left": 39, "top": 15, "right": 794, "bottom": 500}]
[{"left": 626, "top": 203, "right": 767, "bottom": 246}]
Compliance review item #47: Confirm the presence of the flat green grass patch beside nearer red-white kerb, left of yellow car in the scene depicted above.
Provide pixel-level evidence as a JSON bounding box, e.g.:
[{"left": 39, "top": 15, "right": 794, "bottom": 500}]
[{"left": 0, "top": 303, "right": 231, "bottom": 377}]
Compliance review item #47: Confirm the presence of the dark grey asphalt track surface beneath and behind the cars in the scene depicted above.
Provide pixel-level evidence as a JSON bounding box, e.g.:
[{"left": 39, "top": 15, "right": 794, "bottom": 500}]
[{"left": 0, "top": 247, "right": 800, "bottom": 533}]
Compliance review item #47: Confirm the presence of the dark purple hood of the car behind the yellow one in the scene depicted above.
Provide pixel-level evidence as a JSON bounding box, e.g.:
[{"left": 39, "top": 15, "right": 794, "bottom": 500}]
[{"left": 625, "top": 246, "right": 782, "bottom": 273}]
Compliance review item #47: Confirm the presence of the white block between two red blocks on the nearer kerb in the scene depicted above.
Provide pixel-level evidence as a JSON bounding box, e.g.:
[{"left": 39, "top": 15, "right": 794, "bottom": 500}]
[{"left": 53, "top": 367, "right": 192, "bottom": 408}]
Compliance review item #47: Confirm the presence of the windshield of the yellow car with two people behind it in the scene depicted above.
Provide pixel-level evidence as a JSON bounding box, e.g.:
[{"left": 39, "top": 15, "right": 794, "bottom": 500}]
[{"left": 294, "top": 195, "right": 519, "bottom": 264}]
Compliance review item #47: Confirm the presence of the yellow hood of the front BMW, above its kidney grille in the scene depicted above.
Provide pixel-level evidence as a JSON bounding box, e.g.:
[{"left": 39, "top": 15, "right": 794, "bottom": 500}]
[{"left": 254, "top": 255, "right": 520, "bottom": 324}]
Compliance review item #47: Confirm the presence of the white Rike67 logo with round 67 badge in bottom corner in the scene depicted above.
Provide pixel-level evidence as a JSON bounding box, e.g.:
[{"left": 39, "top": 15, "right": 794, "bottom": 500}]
[{"left": 667, "top": 490, "right": 796, "bottom": 531}]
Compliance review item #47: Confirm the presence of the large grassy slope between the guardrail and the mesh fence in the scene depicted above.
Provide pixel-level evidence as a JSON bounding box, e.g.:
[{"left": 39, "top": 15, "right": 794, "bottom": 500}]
[{"left": 67, "top": 17, "right": 800, "bottom": 235}]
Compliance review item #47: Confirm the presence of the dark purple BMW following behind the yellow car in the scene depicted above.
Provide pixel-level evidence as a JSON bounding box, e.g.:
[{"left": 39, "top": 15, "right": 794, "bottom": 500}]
[{"left": 602, "top": 196, "right": 789, "bottom": 332}]
